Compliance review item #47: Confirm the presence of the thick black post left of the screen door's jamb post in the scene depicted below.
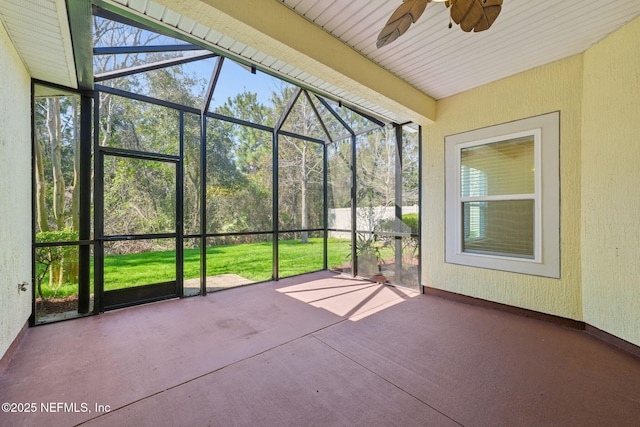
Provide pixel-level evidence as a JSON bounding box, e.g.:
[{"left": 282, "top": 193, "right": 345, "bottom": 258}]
[{"left": 78, "top": 93, "right": 92, "bottom": 314}]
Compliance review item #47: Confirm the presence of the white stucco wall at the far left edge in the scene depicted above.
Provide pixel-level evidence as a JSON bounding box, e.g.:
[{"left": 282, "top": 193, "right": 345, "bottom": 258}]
[{"left": 0, "top": 24, "right": 31, "bottom": 357}]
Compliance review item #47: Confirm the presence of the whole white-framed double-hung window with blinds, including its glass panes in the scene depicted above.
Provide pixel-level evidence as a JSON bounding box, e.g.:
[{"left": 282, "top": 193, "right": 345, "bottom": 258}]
[{"left": 445, "top": 112, "right": 560, "bottom": 278}]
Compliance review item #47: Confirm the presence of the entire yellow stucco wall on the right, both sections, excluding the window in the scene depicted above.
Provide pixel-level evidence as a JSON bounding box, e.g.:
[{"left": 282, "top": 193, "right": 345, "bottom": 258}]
[{"left": 422, "top": 18, "right": 640, "bottom": 345}]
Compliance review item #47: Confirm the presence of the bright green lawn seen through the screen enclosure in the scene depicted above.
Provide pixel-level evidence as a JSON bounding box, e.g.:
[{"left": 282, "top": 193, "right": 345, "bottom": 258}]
[{"left": 37, "top": 238, "right": 351, "bottom": 297}]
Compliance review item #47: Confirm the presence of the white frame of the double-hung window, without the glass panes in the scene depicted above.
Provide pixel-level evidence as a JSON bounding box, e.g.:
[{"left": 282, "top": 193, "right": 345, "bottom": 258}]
[{"left": 445, "top": 112, "right": 560, "bottom": 278}]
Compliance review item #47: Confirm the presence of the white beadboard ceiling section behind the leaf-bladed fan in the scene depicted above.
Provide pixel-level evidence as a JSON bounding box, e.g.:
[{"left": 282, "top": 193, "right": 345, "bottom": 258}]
[{"left": 282, "top": 0, "right": 640, "bottom": 99}]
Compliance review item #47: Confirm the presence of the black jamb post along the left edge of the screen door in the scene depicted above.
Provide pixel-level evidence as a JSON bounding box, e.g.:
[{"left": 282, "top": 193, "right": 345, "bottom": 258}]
[{"left": 93, "top": 92, "right": 104, "bottom": 314}]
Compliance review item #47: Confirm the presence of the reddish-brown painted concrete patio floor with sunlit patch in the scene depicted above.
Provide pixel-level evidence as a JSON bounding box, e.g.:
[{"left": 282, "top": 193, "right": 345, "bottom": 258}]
[{"left": 0, "top": 272, "right": 640, "bottom": 426}]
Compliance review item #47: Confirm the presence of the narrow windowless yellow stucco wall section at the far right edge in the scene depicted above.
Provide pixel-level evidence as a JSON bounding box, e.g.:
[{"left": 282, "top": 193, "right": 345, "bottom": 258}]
[{"left": 582, "top": 18, "right": 640, "bottom": 345}]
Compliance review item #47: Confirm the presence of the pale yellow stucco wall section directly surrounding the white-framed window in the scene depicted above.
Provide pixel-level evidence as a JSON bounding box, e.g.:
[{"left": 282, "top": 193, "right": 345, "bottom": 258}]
[{"left": 422, "top": 55, "right": 583, "bottom": 320}]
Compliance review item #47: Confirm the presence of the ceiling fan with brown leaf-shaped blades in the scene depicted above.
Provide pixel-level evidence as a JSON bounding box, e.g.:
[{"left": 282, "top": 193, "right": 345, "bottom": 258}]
[{"left": 376, "top": 0, "right": 502, "bottom": 48}]
